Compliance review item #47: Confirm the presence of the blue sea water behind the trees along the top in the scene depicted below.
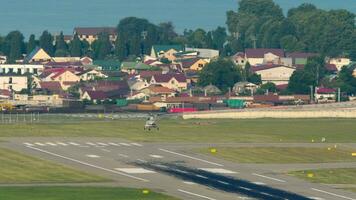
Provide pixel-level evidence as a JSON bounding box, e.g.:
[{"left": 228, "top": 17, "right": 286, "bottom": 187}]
[{"left": 0, "top": 0, "right": 356, "bottom": 36}]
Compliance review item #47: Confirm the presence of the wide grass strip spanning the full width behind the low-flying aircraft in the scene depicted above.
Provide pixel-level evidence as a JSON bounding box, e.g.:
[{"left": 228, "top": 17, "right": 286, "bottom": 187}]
[{"left": 0, "top": 119, "right": 356, "bottom": 143}]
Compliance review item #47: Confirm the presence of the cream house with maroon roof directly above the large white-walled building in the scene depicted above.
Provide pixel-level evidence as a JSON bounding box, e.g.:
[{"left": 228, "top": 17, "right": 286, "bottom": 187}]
[{"left": 245, "top": 49, "right": 285, "bottom": 66}]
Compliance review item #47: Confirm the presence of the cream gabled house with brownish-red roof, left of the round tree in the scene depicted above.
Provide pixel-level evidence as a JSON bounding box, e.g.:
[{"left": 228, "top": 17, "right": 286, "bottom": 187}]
[{"left": 150, "top": 73, "right": 188, "bottom": 91}]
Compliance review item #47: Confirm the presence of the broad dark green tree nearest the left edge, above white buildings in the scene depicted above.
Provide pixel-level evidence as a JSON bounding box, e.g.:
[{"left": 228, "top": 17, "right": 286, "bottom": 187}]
[{"left": 4, "top": 31, "right": 25, "bottom": 63}]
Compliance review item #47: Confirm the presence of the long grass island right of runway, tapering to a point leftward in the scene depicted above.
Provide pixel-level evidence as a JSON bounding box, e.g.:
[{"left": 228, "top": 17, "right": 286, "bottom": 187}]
[{"left": 196, "top": 147, "right": 356, "bottom": 164}]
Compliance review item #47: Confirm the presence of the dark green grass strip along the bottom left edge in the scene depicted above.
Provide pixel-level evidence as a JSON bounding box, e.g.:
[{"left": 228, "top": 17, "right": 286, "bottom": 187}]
[{"left": 0, "top": 187, "right": 177, "bottom": 200}]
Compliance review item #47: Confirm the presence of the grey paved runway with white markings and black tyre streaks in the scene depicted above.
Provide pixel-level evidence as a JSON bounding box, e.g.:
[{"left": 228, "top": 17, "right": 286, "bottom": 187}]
[{"left": 0, "top": 138, "right": 356, "bottom": 200}]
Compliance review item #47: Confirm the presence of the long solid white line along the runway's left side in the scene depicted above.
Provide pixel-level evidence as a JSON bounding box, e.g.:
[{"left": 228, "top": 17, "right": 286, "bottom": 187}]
[{"left": 27, "top": 146, "right": 149, "bottom": 182}]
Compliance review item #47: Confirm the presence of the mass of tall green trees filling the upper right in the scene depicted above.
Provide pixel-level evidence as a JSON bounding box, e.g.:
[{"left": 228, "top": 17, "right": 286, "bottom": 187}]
[{"left": 226, "top": 0, "right": 356, "bottom": 59}]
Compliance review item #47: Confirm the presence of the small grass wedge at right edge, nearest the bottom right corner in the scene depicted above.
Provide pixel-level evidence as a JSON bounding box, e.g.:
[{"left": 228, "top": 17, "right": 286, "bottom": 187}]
[{"left": 289, "top": 168, "right": 356, "bottom": 184}]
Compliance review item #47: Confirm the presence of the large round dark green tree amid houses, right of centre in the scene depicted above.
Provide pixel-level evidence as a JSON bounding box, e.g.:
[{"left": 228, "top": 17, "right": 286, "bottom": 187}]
[{"left": 198, "top": 58, "right": 241, "bottom": 91}]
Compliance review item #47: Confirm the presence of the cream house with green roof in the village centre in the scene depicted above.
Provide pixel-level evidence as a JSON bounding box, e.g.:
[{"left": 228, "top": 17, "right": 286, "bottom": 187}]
[{"left": 151, "top": 45, "right": 184, "bottom": 61}]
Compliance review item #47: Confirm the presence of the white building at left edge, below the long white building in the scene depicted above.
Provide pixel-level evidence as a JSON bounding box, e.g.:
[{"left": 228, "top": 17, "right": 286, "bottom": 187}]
[{"left": 0, "top": 73, "right": 28, "bottom": 92}]
